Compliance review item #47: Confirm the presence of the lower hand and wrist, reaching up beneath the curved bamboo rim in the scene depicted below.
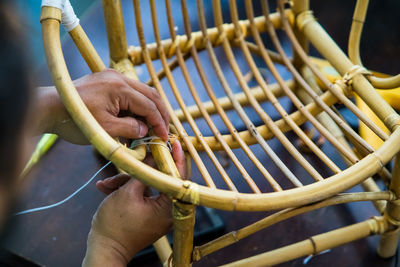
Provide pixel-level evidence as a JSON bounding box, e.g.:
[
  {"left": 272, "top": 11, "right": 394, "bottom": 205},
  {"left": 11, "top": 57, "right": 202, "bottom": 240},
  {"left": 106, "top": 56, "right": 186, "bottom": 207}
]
[{"left": 83, "top": 141, "right": 185, "bottom": 266}]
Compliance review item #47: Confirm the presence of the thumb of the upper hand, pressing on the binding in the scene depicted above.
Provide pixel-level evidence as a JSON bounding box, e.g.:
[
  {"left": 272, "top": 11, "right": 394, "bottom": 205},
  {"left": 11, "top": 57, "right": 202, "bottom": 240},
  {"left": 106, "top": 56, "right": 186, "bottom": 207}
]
[{"left": 105, "top": 116, "right": 149, "bottom": 139}]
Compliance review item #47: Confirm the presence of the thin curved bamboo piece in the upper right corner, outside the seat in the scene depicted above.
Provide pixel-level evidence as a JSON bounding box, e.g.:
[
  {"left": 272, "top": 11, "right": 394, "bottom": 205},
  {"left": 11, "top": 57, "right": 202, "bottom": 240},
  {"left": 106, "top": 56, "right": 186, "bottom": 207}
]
[{"left": 348, "top": 0, "right": 400, "bottom": 89}]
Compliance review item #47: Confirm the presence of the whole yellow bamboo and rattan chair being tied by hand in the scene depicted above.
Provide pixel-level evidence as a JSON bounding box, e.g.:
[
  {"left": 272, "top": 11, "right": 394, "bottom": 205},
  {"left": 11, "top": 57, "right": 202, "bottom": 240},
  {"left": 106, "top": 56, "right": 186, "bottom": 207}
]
[{"left": 41, "top": 0, "right": 400, "bottom": 266}]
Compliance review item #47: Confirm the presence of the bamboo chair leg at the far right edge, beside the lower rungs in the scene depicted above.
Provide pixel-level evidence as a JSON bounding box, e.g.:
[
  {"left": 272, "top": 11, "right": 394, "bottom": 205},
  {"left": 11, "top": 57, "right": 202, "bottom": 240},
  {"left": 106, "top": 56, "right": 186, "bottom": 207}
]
[{"left": 377, "top": 154, "right": 400, "bottom": 258}]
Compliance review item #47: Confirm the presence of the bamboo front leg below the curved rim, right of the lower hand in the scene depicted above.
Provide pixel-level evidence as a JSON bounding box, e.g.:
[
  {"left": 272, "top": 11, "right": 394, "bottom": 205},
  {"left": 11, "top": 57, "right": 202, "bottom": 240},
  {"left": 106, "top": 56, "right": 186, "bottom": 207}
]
[{"left": 172, "top": 200, "right": 196, "bottom": 267}]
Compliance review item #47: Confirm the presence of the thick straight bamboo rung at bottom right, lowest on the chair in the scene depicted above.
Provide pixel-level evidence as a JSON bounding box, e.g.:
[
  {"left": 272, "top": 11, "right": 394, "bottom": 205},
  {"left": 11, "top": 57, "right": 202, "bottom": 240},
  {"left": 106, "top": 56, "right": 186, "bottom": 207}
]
[{"left": 222, "top": 217, "right": 387, "bottom": 267}]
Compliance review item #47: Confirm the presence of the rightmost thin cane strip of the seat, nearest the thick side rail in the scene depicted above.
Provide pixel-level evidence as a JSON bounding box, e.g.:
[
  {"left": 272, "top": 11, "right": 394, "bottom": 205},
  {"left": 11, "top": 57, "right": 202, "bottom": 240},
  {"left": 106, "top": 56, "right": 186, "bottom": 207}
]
[{"left": 278, "top": 2, "right": 388, "bottom": 140}]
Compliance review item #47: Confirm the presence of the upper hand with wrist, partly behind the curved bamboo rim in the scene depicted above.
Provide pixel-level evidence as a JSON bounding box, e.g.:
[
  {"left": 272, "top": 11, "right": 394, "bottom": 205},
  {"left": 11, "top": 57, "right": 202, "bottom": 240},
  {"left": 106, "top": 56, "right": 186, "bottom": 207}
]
[{"left": 36, "top": 70, "right": 169, "bottom": 144}]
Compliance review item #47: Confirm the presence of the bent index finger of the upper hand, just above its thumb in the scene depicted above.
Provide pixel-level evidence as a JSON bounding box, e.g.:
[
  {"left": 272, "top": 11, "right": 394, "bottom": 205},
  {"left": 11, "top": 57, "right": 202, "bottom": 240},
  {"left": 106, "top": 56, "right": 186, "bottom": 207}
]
[{"left": 120, "top": 90, "right": 168, "bottom": 141}]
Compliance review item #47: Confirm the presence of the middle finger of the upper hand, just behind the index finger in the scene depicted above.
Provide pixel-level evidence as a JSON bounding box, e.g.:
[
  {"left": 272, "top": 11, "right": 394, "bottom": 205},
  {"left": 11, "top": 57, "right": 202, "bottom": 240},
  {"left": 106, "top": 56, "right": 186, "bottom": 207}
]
[{"left": 119, "top": 76, "right": 169, "bottom": 128}]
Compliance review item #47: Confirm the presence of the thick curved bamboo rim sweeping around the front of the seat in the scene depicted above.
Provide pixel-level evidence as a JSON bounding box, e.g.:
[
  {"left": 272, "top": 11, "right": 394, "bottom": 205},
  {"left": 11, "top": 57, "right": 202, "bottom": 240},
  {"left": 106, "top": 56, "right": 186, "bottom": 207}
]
[{"left": 41, "top": 7, "right": 400, "bottom": 211}]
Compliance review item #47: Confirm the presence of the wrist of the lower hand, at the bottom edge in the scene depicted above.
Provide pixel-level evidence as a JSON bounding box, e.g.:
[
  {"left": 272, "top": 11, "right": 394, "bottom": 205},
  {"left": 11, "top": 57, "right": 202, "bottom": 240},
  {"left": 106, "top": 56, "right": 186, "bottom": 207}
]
[{"left": 82, "top": 229, "right": 133, "bottom": 267}]
